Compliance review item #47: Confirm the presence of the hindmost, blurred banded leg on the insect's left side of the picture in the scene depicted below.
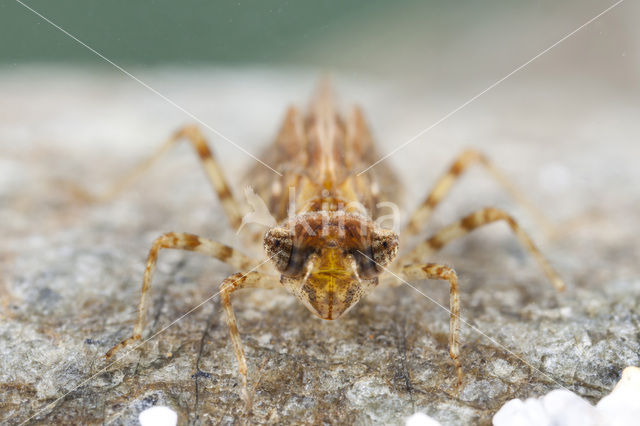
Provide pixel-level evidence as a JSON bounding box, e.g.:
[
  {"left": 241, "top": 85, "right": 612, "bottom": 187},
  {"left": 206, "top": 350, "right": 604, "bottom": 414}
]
[{"left": 71, "top": 125, "right": 242, "bottom": 229}]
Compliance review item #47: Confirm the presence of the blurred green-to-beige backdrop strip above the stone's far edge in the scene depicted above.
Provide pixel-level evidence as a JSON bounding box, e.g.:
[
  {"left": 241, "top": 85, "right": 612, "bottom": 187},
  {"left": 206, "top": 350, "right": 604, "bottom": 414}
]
[{"left": 0, "top": 0, "right": 640, "bottom": 88}]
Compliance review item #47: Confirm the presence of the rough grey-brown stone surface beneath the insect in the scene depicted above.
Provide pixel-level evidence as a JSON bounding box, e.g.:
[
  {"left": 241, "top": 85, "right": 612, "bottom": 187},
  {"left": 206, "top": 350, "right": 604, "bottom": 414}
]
[{"left": 0, "top": 71, "right": 640, "bottom": 424}]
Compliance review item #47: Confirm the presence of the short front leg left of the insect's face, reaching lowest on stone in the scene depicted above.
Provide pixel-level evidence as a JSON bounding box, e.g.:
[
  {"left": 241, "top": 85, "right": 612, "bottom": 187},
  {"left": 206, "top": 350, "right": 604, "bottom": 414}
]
[{"left": 220, "top": 272, "right": 280, "bottom": 410}]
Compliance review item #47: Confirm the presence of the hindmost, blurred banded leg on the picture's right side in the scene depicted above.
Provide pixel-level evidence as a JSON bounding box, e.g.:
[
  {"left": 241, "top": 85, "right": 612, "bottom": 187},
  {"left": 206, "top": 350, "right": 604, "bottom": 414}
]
[{"left": 405, "top": 149, "right": 552, "bottom": 235}]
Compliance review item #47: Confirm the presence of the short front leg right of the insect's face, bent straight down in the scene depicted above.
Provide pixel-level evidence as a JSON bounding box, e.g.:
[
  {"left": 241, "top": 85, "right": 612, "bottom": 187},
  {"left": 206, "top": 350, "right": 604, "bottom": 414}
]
[{"left": 400, "top": 263, "right": 463, "bottom": 388}]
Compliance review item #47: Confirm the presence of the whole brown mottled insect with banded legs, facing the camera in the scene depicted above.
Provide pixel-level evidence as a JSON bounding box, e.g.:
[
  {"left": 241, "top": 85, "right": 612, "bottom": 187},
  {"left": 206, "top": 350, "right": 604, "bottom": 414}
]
[{"left": 106, "top": 80, "right": 564, "bottom": 403}]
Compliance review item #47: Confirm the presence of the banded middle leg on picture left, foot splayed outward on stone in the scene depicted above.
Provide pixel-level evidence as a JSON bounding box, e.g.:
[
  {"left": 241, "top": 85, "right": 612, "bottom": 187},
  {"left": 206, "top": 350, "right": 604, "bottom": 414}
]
[{"left": 105, "top": 232, "right": 256, "bottom": 359}]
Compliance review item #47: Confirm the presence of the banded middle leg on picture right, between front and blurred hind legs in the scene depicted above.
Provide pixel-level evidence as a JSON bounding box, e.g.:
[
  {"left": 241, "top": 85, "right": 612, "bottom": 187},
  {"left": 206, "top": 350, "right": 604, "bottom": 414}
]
[{"left": 401, "top": 207, "right": 565, "bottom": 291}]
